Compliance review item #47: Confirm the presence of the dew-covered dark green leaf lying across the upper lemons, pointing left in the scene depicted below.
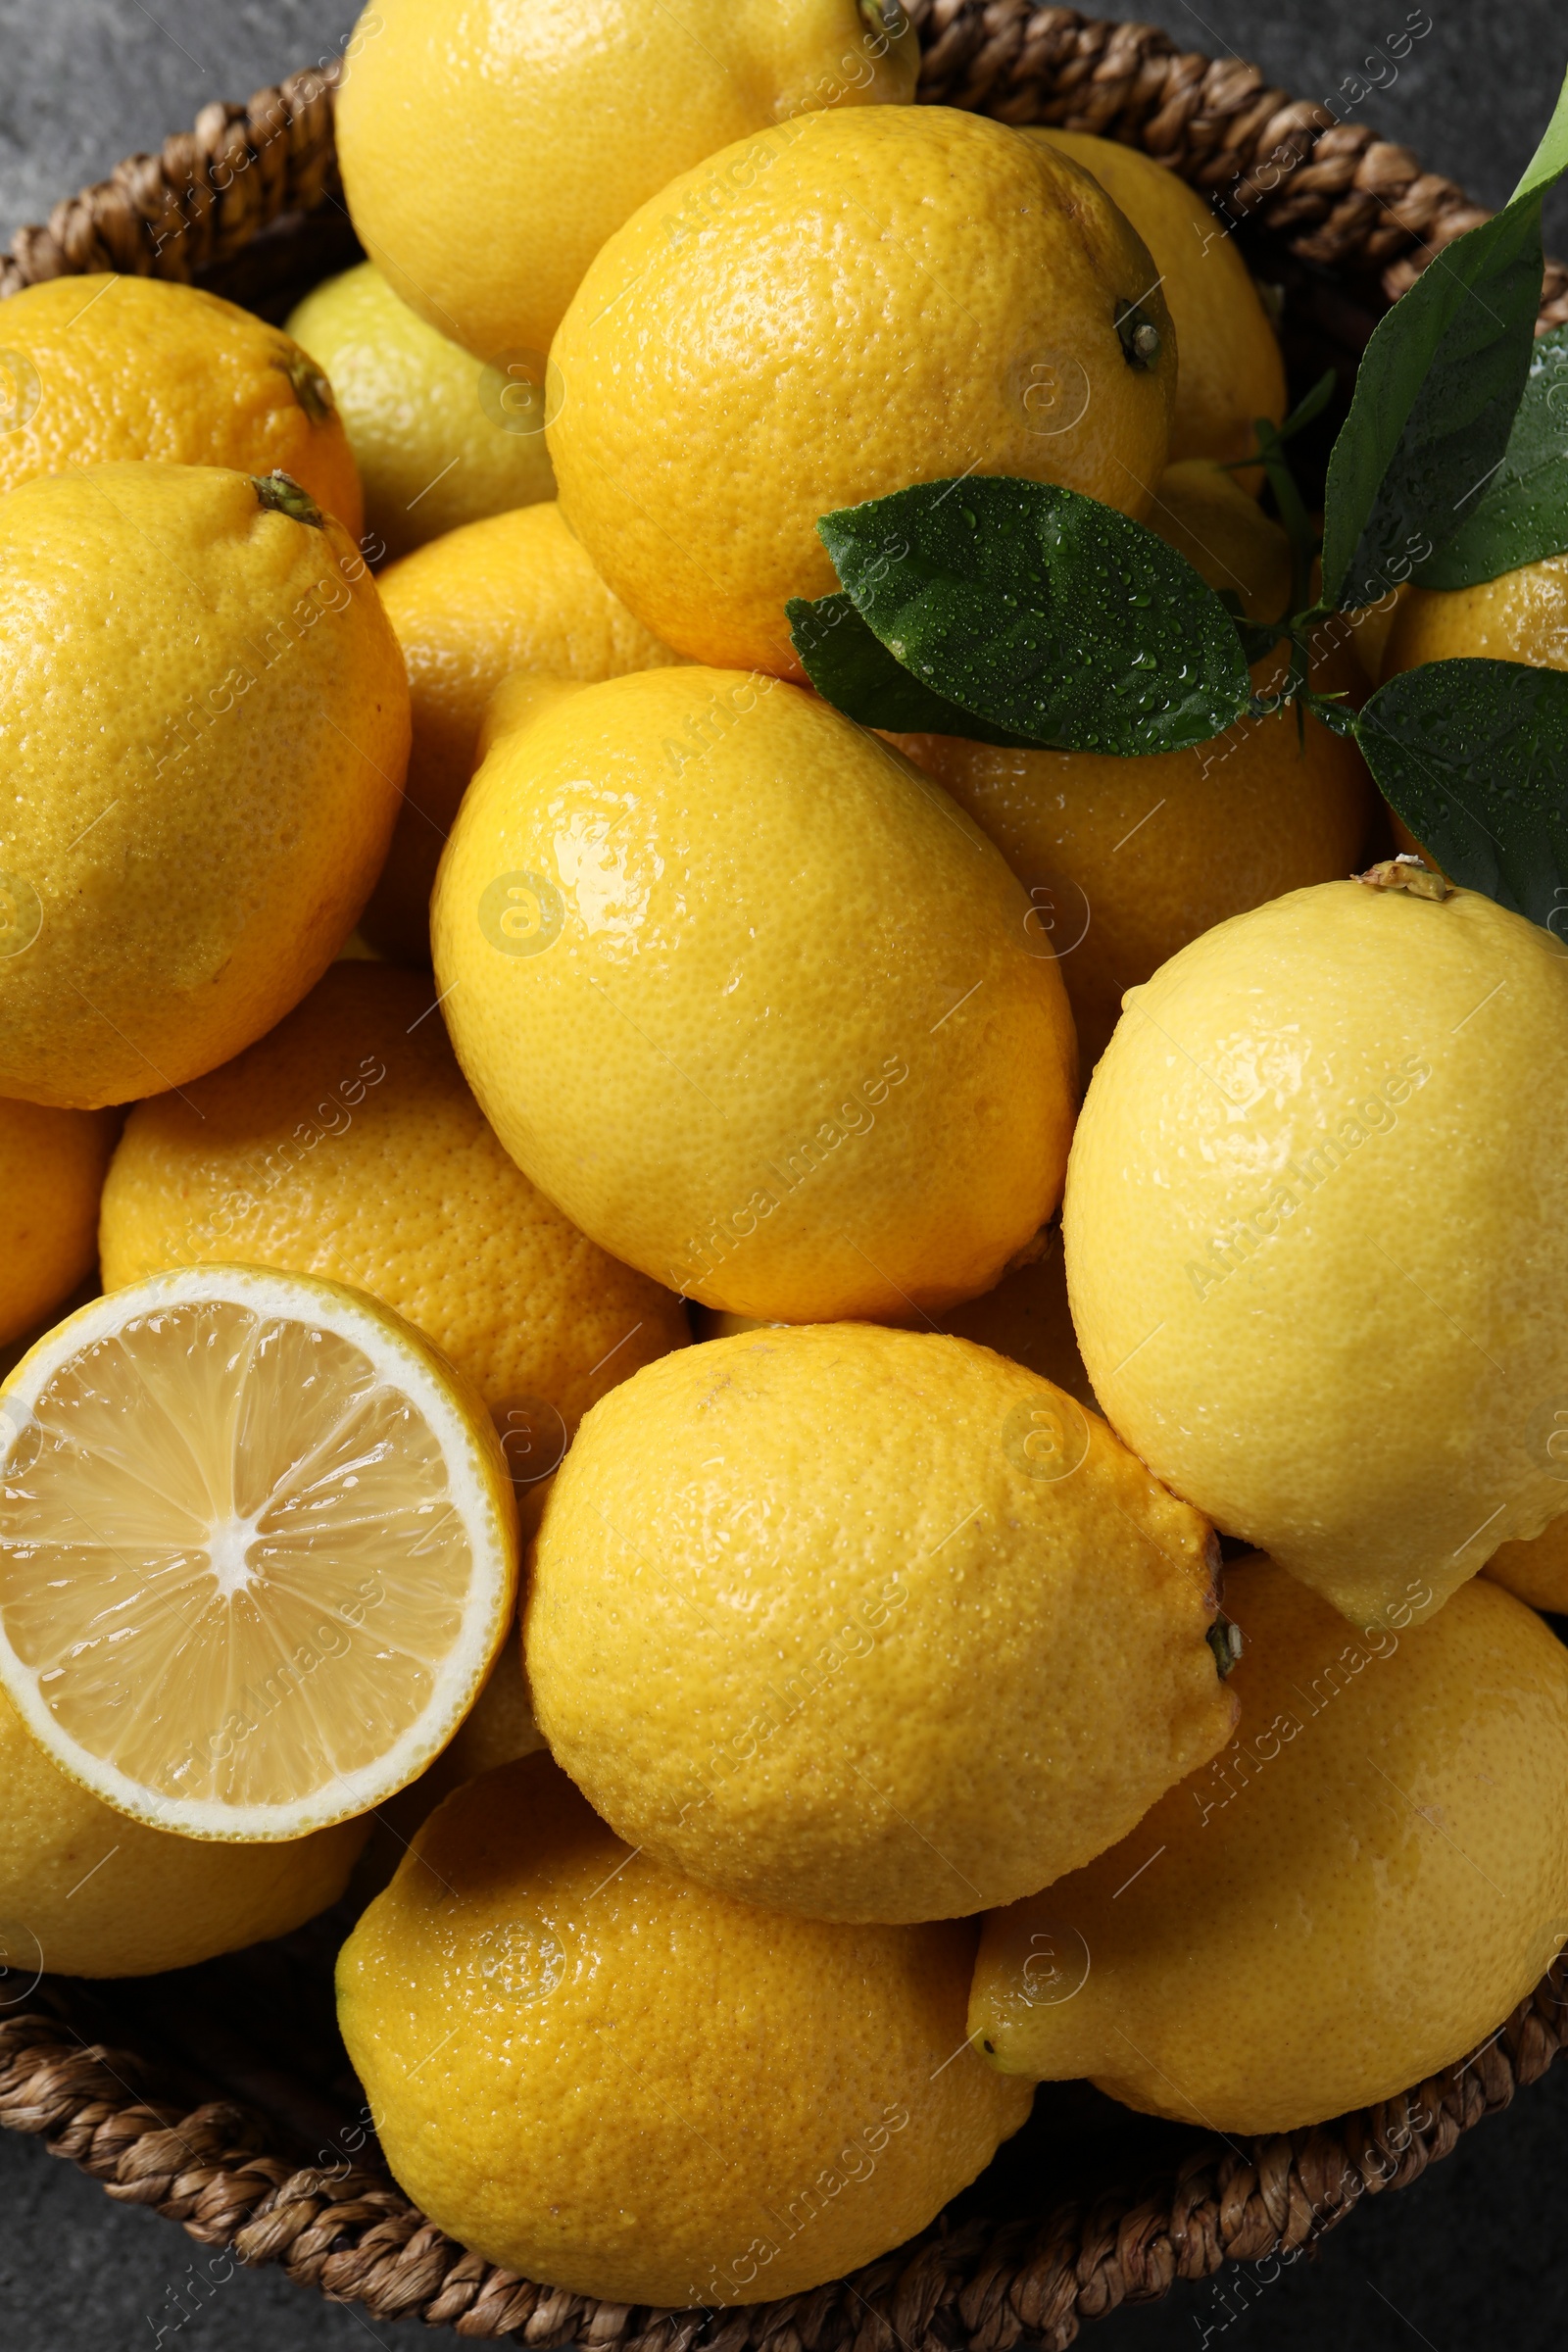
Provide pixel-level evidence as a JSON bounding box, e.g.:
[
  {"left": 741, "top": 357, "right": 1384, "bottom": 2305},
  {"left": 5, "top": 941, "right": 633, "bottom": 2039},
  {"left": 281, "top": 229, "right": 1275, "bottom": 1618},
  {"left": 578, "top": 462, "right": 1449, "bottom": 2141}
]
[{"left": 818, "top": 475, "right": 1250, "bottom": 755}]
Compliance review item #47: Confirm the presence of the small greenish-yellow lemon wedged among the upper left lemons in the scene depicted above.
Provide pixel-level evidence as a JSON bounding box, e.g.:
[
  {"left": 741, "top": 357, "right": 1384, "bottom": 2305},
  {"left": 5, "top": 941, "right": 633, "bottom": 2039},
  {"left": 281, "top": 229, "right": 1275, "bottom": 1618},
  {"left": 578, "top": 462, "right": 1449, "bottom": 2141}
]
[{"left": 289, "top": 261, "right": 555, "bottom": 555}]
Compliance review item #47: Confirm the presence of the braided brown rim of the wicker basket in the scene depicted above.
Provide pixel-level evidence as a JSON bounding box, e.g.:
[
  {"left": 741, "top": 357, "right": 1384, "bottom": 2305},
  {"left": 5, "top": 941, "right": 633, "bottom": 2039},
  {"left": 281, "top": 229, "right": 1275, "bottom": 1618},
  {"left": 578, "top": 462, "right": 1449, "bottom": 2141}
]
[{"left": 0, "top": 0, "right": 1568, "bottom": 2352}]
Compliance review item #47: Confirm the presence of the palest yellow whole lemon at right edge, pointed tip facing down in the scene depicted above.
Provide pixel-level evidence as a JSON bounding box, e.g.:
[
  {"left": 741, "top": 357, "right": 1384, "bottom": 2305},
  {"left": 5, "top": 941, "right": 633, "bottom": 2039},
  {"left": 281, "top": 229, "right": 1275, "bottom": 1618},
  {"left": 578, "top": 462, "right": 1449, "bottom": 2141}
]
[{"left": 1065, "top": 882, "right": 1568, "bottom": 1625}]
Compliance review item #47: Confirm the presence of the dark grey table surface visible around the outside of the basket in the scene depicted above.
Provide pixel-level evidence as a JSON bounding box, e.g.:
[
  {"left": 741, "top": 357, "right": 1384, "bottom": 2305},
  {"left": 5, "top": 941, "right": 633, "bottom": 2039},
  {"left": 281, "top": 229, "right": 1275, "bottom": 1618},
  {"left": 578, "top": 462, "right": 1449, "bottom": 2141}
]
[{"left": 0, "top": 0, "right": 1568, "bottom": 2352}]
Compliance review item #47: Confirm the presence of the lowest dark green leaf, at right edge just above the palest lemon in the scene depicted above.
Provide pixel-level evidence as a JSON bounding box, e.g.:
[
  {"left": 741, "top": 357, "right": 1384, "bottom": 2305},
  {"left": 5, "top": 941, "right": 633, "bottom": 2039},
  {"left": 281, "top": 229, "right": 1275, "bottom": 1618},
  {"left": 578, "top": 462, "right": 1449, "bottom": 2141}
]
[{"left": 1356, "top": 661, "right": 1568, "bottom": 929}]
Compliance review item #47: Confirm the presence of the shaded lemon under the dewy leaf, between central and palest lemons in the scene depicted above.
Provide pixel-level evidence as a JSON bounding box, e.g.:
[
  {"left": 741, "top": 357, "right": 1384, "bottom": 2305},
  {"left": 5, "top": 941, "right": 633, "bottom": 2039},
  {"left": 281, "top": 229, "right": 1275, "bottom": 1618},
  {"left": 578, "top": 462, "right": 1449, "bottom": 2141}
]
[{"left": 894, "top": 635, "right": 1375, "bottom": 1070}]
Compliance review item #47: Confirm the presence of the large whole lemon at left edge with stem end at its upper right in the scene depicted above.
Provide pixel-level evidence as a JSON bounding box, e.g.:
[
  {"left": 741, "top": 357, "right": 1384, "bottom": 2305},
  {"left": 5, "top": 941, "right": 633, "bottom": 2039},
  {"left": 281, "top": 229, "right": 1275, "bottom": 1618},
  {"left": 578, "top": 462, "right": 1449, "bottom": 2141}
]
[{"left": 0, "top": 464, "right": 409, "bottom": 1107}]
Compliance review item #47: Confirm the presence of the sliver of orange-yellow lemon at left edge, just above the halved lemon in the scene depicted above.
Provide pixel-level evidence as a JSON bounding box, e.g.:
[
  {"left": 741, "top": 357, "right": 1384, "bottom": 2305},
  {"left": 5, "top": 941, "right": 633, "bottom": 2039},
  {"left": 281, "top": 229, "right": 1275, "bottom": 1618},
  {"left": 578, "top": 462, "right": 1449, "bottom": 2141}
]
[{"left": 0, "top": 1101, "right": 118, "bottom": 1346}]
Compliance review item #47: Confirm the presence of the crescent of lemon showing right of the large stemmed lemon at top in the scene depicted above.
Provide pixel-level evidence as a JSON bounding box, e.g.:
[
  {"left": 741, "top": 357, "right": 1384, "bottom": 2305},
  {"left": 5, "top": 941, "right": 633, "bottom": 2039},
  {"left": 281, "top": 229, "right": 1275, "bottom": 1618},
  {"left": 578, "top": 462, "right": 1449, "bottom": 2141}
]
[{"left": 1027, "top": 129, "right": 1286, "bottom": 487}]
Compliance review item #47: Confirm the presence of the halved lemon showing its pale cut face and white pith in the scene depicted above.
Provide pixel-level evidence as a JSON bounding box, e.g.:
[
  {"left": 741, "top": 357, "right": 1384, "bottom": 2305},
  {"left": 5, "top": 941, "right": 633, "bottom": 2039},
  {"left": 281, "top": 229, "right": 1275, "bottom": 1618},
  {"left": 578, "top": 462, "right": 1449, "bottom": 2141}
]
[{"left": 0, "top": 1265, "right": 517, "bottom": 1839}]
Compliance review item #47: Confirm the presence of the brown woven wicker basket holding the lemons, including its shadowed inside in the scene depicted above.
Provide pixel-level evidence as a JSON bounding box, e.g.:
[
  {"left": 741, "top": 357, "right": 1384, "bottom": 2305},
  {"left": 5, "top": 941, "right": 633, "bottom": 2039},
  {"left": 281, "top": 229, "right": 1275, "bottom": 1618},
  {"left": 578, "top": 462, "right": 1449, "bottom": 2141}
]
[{"left": 0, "top": 0, "right": 1568, "bottom": 2352}]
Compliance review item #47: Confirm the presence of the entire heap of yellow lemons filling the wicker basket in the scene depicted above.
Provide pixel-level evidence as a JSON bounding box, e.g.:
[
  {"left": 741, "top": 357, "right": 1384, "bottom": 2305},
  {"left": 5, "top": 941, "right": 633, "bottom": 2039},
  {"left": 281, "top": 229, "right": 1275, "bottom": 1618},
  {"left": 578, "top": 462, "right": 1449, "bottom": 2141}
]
[{"left": 0, "top": 0, "right": 1568, "bottom": 2307}]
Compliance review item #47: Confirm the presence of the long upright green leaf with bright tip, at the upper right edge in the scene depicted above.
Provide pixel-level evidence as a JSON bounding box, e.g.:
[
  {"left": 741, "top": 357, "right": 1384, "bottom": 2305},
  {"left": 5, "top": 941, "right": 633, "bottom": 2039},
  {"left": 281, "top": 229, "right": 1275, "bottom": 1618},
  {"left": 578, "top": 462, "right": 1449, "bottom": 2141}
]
[{"left": 1324, "top": 65, "right": 1568, "bottom": 607}]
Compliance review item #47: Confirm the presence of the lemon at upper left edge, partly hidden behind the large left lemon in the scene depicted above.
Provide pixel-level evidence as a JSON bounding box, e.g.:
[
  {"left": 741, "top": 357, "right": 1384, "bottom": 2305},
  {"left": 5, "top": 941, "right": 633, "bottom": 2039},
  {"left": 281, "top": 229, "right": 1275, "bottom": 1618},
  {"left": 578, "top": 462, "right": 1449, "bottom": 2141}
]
[{"left": 0, "top": 272, "right": 365, "bottom": 539}]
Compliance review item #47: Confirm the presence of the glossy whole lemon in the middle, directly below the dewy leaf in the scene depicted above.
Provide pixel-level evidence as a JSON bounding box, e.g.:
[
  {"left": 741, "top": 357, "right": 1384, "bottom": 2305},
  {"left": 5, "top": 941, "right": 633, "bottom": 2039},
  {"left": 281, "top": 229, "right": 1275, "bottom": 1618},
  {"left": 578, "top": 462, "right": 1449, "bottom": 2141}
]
[{"left": 432, "top": 668, "right": 1077, "bottom": 1322}]
